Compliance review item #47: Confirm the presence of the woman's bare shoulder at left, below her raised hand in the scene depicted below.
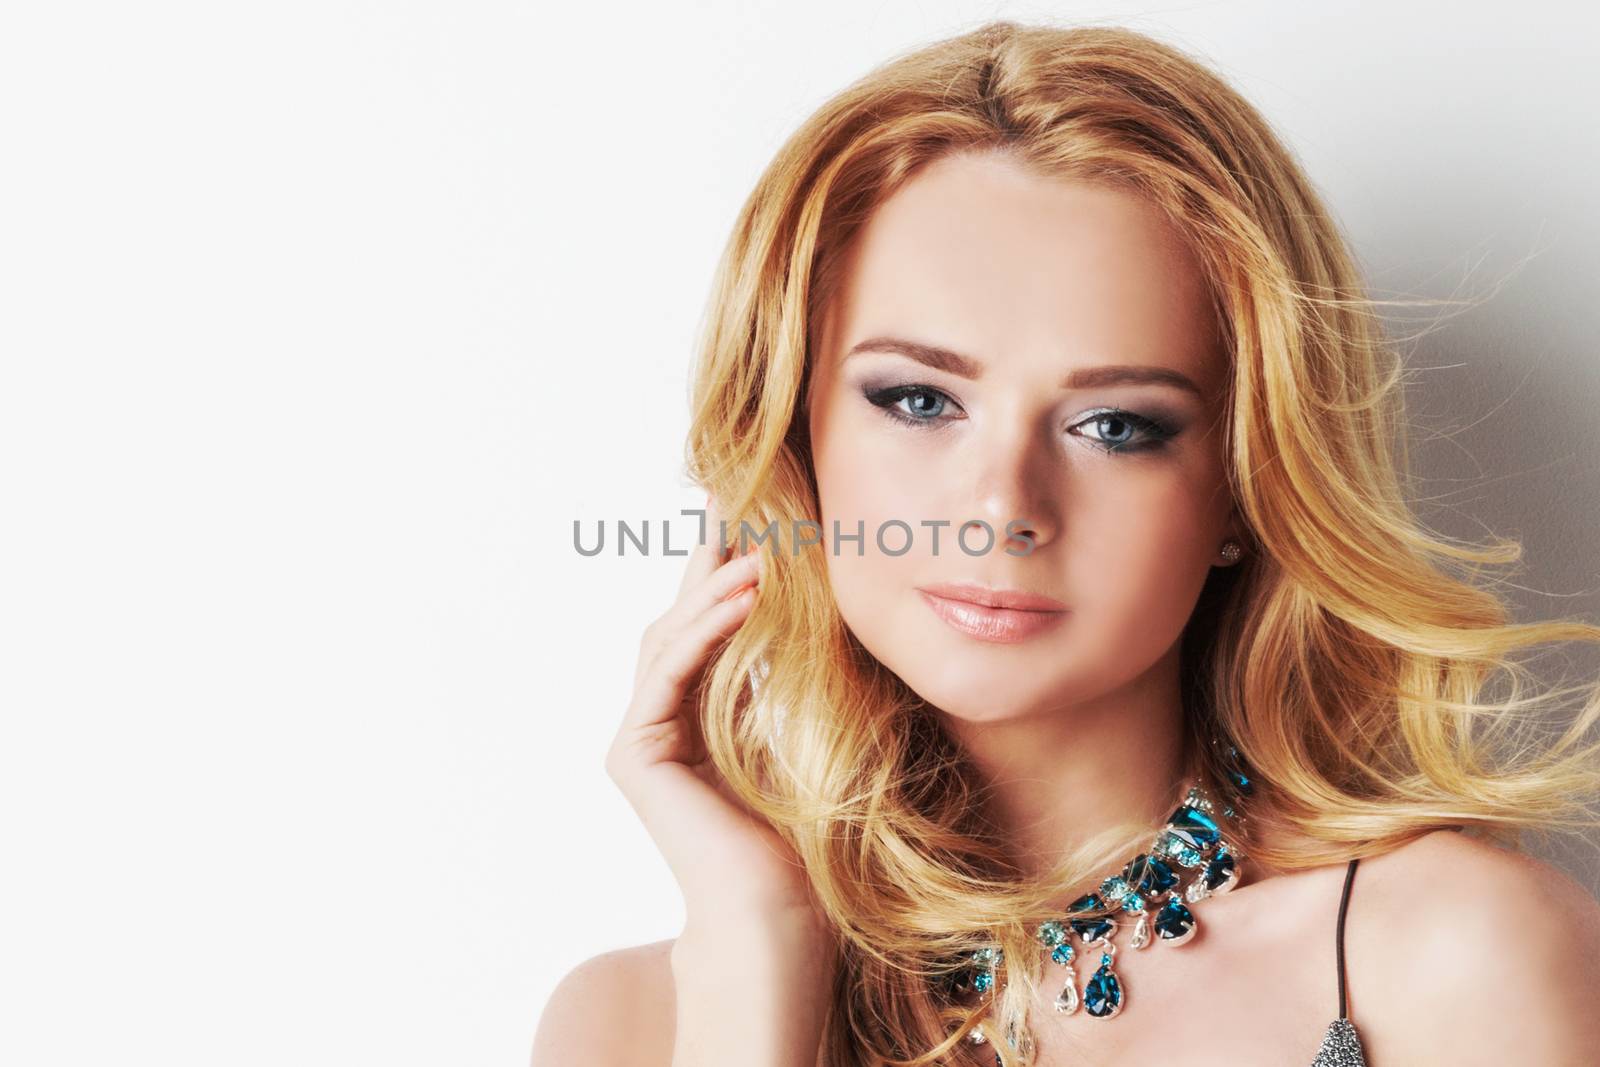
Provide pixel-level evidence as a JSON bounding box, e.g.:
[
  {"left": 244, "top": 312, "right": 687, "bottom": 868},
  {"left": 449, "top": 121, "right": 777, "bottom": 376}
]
[{"left": 531, "top": 937, "right": 677, "bottom": 1067}]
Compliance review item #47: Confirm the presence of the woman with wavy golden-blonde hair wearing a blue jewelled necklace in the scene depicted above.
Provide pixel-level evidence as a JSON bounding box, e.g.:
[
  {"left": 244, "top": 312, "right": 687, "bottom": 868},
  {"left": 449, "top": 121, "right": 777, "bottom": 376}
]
[{"left": 534, "top": 22, "right": 1600, "bottom": 1067}]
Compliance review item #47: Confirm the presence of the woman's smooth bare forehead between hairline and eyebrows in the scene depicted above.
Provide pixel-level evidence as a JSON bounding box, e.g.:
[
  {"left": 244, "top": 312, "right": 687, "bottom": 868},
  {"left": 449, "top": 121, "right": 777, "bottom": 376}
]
[{"left": 819, "top": 155, "right": 1222, "bottom": 404}]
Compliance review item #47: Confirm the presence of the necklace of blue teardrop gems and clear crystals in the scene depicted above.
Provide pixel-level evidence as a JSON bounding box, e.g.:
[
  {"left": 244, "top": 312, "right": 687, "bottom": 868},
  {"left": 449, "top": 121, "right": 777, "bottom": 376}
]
[{"left": 955, "top": 747, "right": 1254, "bottom": 1064}]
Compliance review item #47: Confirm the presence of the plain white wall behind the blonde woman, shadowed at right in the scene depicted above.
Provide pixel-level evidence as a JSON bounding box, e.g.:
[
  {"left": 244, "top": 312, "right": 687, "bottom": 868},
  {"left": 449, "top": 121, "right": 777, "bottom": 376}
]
[{"left": 0, "top": 0, "right": 1600, "bottom": 1067}]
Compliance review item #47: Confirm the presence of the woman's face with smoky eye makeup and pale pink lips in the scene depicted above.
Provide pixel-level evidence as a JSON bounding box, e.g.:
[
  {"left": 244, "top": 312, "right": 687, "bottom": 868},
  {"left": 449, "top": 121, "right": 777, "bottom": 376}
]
[{"left": 806, "top": 155, "right": 1237, "bottom": 721}]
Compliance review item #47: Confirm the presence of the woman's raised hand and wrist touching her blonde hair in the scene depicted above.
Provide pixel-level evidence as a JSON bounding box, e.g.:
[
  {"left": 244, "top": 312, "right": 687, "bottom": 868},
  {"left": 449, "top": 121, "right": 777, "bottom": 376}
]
[{"left": 605, "top": 501, "right": 822, "bottom": 933}]
